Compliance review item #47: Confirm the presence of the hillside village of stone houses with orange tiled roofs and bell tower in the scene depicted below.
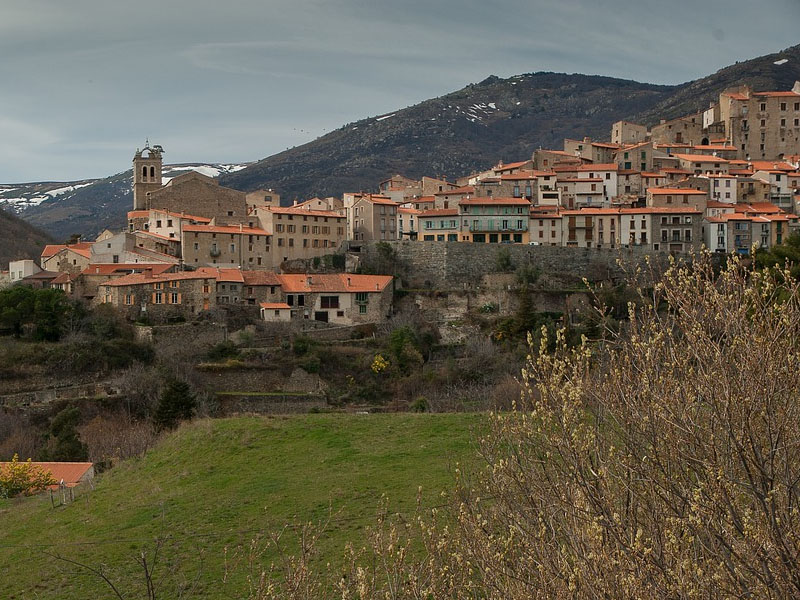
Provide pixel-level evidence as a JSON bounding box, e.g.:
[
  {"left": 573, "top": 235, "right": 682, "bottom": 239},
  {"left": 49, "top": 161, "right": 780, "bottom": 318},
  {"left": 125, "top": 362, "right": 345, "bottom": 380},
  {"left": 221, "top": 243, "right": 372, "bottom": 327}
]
[{"left": 3, "top": 82, "right": 800, "bottom": 324}]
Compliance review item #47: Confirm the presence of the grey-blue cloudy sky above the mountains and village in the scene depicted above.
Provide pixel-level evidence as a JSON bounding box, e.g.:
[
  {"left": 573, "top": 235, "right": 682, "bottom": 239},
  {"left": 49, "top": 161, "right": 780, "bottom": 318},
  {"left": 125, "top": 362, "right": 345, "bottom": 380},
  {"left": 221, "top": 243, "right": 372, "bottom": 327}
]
[{"left": 0, "top": 0, "right": 800, "bottom": 183}]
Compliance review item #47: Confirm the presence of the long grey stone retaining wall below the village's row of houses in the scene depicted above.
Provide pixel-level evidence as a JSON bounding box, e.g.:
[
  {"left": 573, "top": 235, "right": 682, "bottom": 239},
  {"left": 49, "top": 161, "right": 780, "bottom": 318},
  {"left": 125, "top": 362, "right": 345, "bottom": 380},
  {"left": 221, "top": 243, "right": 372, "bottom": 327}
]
[{"left": 356, "top": 241, "right": 668, "bottom": 290}]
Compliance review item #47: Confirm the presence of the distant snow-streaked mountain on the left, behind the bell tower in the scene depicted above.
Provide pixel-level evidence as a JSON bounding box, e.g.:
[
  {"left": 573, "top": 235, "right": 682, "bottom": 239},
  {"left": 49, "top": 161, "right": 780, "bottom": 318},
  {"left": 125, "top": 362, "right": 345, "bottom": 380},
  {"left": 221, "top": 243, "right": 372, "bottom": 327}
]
[{"left": 0, "top": 163, "right": 246, "bottom": 240}]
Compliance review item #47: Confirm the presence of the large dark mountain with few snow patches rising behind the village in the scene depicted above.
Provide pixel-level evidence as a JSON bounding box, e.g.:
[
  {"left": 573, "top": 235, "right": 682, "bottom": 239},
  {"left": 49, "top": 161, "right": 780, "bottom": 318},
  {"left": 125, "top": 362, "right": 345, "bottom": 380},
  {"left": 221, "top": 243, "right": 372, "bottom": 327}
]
[{"left": 221, "top": 45, "right": 800, "bottom": 199}]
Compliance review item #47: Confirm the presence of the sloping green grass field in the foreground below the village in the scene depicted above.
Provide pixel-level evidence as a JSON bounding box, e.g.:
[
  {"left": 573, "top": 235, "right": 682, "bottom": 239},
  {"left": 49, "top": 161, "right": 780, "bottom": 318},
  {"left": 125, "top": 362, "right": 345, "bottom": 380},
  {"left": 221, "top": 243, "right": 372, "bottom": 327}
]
[{"left": 0, "top": 414, "right": 483, "bottom": 599}]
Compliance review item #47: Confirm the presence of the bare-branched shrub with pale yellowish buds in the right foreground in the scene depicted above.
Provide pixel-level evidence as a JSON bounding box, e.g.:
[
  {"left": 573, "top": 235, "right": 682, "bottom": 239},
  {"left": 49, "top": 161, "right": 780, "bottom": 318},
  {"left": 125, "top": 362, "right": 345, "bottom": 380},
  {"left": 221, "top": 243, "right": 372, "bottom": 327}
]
[{"left": 220, "top": 257, "right": 800, "bottom": 600}]
